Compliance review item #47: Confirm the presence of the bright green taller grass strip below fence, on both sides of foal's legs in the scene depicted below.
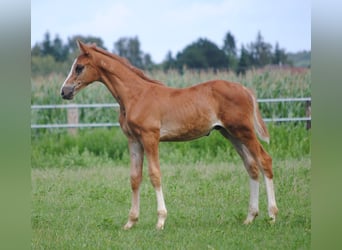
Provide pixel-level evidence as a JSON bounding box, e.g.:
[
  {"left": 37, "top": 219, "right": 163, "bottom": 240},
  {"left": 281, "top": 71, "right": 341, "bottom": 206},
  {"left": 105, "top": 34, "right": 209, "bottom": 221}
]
[{"left": 31, "top": 124, "right": 311, "bottom": 168}]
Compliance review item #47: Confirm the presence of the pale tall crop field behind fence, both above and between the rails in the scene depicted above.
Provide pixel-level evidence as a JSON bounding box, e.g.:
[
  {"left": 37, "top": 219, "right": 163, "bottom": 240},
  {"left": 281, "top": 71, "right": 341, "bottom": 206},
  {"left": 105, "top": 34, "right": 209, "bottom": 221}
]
[{"left": 31, "top": 70, "right": 311, "bottom": 133}]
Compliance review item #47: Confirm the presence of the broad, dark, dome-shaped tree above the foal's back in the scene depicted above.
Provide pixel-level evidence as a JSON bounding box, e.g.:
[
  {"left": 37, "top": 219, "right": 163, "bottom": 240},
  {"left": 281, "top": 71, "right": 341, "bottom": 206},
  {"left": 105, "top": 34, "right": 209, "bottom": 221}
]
[{"left": 177, "top": 38, "right": 228, "bottom": 69}]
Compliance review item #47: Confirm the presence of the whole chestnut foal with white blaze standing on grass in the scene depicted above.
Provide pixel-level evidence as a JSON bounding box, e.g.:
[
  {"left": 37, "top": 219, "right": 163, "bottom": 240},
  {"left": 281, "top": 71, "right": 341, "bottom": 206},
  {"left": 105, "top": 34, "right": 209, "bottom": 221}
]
[{"left": 60, "top": 41, "right": 278, "bottom": 230}]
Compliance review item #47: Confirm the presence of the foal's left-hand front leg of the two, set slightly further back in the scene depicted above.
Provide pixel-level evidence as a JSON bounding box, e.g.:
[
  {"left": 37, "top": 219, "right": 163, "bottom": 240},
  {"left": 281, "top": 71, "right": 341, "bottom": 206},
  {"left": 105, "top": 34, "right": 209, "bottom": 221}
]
[{"left": 124, "top": 140, "right": 144, "bottom": 230}]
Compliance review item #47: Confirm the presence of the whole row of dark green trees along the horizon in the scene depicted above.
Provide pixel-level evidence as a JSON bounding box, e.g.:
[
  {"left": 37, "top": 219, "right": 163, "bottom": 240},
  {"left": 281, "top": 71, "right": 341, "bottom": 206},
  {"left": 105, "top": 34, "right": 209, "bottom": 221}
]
[{"left": 31, "top": 31, "right": 292, "bottom": 75}]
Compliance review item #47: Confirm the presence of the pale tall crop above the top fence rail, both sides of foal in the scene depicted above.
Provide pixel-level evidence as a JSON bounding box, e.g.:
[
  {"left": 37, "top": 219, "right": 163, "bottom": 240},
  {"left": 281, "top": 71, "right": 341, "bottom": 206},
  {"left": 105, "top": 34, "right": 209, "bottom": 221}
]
[{"left": 31, "top": 70, "right": 311, "bottom": 104}]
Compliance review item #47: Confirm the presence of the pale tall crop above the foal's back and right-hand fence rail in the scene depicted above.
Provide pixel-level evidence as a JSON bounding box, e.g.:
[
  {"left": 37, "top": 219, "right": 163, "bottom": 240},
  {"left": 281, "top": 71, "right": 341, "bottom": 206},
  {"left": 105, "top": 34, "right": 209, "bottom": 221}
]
[{"left": 149, "top": 69, "right": 311, "bottom": 98}]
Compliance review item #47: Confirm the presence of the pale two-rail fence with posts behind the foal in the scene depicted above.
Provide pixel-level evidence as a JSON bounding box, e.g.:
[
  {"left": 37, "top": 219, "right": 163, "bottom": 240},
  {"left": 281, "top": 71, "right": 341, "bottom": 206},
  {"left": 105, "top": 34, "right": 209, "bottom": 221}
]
[{"left": 31, "top": 97, "right": 311, "bottom": 129}]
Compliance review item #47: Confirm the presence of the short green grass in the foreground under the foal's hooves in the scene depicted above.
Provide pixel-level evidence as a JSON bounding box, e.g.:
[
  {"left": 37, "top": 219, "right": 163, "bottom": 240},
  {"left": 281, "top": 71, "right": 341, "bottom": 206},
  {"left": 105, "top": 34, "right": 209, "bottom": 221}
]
[{"left": 32, "top": 158, "right": 311, "bottom": 249}]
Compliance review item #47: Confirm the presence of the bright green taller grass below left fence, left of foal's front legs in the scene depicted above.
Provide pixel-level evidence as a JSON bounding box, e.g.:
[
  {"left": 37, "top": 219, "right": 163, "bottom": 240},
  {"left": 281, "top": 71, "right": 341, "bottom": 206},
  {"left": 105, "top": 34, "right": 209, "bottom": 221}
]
[{"left": 31, "top": 129, "right": 129, "bottom": 168}]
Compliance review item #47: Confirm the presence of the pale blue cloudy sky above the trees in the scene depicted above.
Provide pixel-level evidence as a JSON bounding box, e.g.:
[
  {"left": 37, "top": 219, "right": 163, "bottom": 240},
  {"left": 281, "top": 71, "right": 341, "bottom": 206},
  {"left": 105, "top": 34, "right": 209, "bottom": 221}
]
[{"left": 31, "top": 0, "right": 311, "bottom": 63}]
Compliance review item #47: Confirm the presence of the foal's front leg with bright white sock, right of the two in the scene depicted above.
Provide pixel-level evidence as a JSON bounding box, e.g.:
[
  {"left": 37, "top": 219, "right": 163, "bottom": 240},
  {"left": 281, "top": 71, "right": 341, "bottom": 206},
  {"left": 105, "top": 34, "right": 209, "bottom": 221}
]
[{"left": 143, "top": 135, "right": 167, "bottom": 230}]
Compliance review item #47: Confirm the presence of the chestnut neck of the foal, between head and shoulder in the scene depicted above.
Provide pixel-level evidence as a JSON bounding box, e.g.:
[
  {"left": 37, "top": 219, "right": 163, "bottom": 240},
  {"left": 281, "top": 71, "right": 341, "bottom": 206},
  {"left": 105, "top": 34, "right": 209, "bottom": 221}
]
[{"left": 96, "top": 54, "right": 149, "bottom": 106}]
